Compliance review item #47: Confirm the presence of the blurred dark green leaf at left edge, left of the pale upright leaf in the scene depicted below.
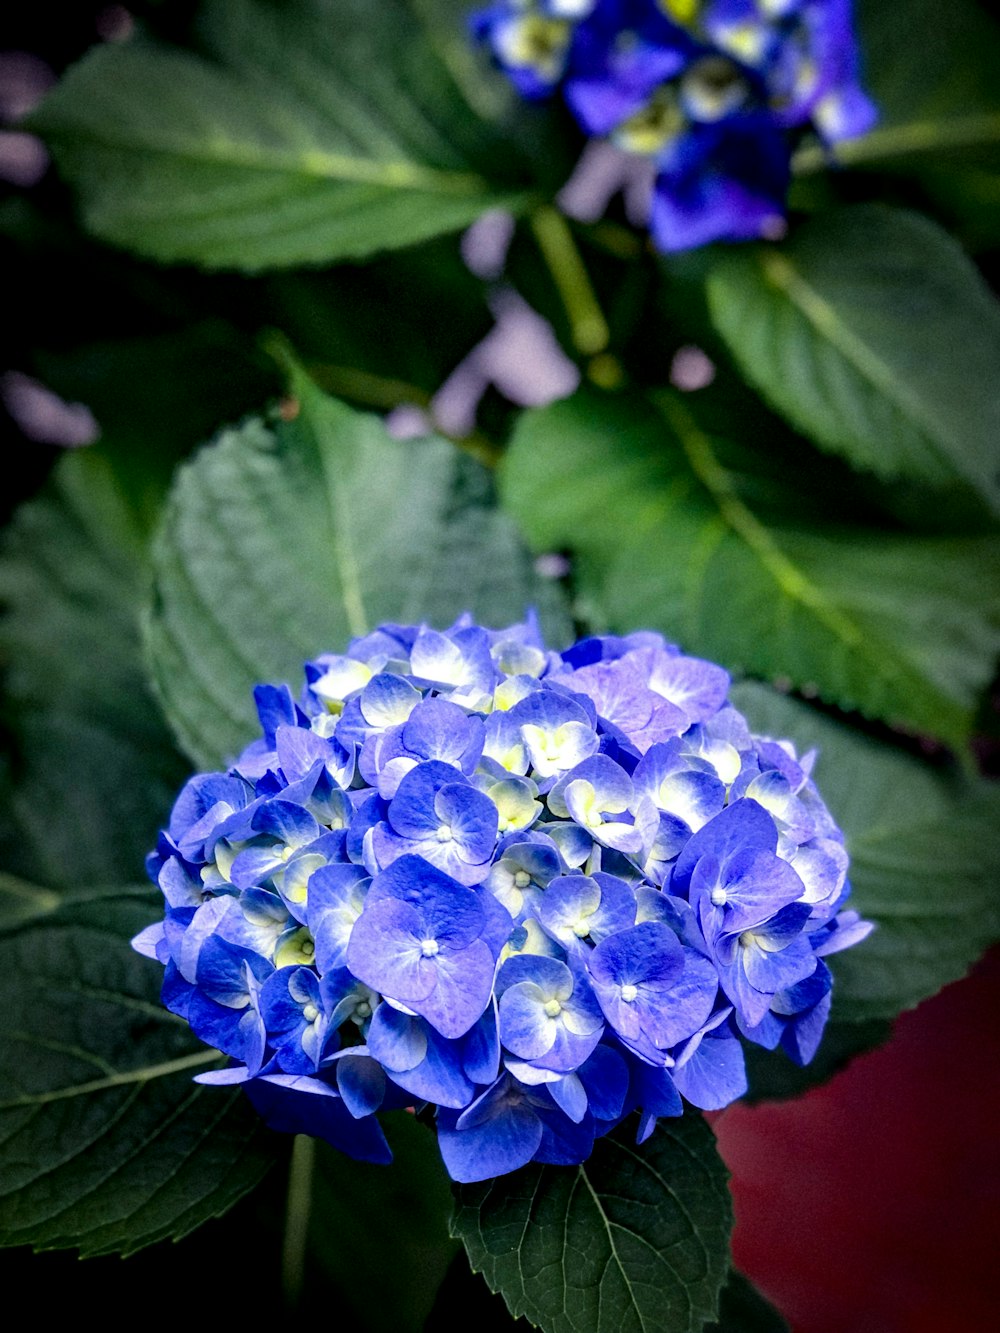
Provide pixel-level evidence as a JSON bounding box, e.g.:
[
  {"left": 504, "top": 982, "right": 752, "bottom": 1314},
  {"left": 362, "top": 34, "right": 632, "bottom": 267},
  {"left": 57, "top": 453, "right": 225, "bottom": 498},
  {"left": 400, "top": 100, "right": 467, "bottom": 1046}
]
[{"left": 0, "top": 448, "right": 184, "bottom": 890}]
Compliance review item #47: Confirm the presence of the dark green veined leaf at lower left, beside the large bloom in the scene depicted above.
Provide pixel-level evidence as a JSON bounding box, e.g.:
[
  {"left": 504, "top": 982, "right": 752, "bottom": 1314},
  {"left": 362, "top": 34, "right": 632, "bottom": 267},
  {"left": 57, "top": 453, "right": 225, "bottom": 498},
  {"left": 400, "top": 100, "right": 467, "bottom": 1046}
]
[{"left": 0, "top": 892, "right": 280, "bottom": 1254}]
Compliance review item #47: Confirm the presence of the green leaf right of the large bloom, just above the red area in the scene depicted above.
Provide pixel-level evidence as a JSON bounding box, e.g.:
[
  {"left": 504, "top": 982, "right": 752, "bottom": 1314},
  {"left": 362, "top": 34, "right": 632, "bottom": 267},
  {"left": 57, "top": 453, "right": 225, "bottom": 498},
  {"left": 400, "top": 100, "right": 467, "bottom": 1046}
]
[{"left": 732, "top": 682, "right": 1000, "bottom": 1022}]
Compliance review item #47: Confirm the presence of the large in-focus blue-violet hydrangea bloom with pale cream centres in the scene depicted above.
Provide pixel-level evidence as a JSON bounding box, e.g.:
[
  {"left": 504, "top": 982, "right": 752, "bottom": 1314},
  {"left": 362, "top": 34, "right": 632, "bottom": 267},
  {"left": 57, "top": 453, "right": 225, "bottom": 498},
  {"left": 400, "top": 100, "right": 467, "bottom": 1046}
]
[{"left": 133, "top": 617, "right": 871, "bottom": 1181}]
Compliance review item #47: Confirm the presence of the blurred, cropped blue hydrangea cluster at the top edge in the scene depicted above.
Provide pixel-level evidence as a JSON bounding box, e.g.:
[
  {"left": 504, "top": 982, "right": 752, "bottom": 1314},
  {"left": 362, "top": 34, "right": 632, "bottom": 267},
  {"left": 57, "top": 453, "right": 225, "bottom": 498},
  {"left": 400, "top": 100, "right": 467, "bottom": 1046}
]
[{"left": 472, "top": 0, "right": 875, "bottom": 251}]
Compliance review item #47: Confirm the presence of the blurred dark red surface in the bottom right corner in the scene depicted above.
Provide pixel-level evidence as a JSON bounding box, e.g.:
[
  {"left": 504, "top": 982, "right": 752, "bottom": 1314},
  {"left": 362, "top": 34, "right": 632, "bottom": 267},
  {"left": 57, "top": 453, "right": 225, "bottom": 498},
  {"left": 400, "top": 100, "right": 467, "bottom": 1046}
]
[{"left": 715, "top": 950, "right": 1000, "bottom": 1333}]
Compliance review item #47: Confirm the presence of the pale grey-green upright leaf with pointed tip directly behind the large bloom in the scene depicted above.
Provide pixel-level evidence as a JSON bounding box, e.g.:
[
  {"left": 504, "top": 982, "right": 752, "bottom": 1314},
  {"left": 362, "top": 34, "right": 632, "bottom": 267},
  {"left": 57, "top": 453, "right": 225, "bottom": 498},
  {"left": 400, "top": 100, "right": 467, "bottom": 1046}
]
[{"left": 148, "top": 362, "right": 571, "bottom": 765}]
